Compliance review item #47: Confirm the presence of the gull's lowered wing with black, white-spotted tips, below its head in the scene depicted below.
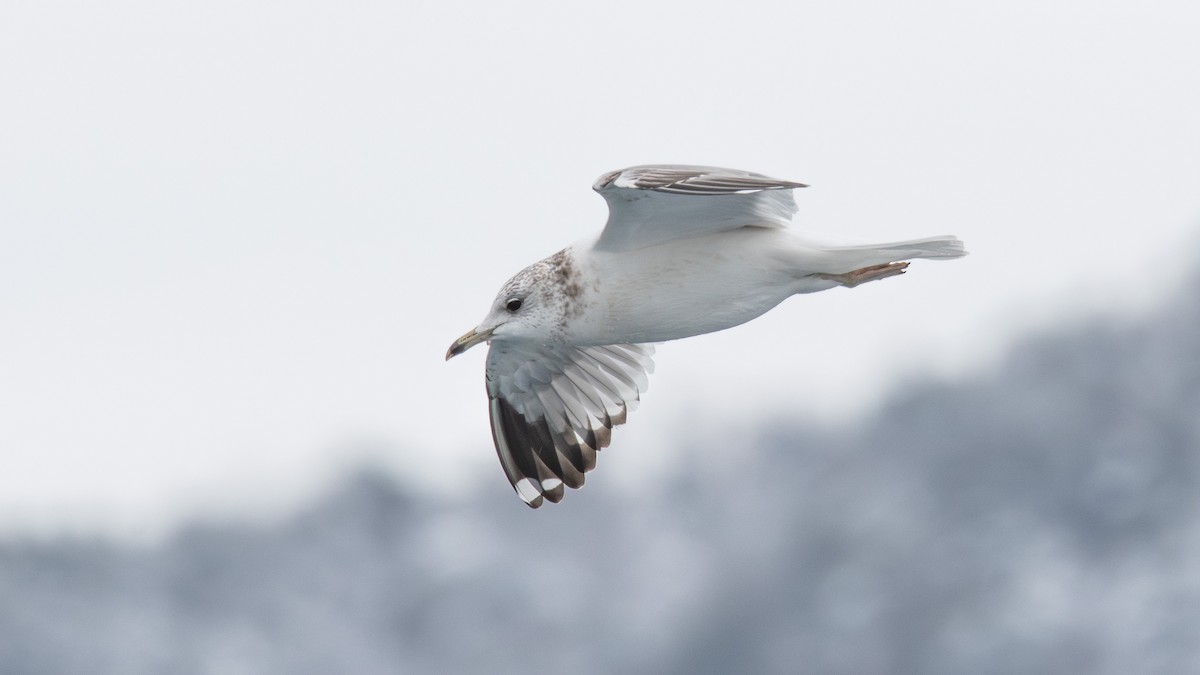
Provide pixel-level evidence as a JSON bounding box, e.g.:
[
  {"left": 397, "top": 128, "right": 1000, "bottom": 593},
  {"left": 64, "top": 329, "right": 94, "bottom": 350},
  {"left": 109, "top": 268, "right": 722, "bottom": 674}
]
[{"left": 486, "top": 342, "right": 654, "bottom": 508}]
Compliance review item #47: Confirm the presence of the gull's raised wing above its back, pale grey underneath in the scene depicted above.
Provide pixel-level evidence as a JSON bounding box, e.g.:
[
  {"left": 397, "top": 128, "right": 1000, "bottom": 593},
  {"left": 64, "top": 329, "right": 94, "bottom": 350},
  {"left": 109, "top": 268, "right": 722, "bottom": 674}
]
[{"left": 592, "top": 165, "right": 805, "bottom": 251}]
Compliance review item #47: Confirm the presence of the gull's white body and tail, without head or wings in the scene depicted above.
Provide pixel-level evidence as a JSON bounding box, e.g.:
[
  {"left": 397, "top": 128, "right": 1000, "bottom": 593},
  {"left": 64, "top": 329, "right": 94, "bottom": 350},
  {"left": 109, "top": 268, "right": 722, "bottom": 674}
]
[{"left": 552, "top": 227, "right": 960, "bottom": 345}]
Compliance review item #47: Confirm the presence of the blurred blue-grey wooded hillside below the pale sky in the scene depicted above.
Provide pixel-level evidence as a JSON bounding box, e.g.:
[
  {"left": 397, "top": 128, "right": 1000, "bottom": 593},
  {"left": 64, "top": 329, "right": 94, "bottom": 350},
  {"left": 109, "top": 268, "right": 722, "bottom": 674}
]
[{"left": 0, "top": 264, "right": 1200, "bottom": 675}]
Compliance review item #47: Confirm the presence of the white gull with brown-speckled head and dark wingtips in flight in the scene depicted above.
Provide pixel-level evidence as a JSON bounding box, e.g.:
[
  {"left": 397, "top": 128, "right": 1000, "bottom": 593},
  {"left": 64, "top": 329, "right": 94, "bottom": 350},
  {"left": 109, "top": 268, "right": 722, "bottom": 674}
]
[{"left": 446, "top": 165, "right": 966, "bottom": 508}]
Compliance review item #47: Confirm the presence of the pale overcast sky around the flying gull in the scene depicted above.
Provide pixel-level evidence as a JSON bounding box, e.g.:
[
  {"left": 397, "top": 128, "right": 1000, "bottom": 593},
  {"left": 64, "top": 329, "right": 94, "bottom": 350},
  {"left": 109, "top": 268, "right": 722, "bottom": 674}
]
[{"left": 7, "top": 0, "right": 1200, "bottom": 536}]
